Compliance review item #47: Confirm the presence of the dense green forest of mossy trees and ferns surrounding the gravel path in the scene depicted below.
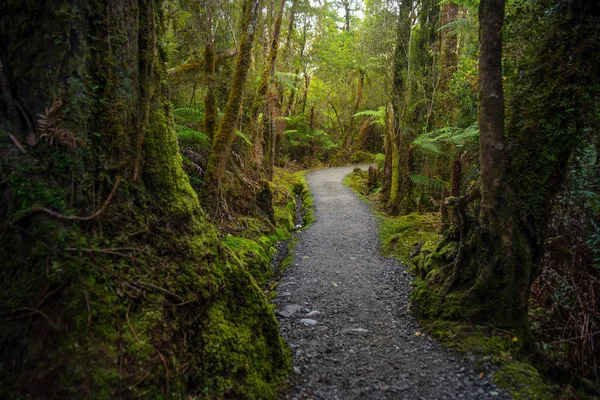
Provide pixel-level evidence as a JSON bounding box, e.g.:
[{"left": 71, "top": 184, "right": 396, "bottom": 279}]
[{"left": 0, "top": 0, "right": 600, "bottom": 398}]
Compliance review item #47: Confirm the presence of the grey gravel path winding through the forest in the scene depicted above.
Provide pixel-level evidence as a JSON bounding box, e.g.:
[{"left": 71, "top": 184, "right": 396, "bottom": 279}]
[{"left": 275, "top": 167, "right": 509, "bottom": 400}]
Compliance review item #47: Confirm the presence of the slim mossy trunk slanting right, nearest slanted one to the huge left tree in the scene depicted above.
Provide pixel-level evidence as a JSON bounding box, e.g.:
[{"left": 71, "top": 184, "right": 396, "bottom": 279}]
[{"left": 204, "top": 0, "right": 260, "bottom": 216}]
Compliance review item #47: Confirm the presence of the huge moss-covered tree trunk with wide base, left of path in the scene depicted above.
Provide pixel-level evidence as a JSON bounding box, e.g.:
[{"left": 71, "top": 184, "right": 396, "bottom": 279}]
[{"left": 0, "top": 0, "right": 288, "bottom": 399}]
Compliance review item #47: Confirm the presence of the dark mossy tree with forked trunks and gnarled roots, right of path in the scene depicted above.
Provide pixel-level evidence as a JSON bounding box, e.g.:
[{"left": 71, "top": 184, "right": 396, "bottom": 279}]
[{"left": 414, "top": 0, "right": 600, "bottom": 338}]
